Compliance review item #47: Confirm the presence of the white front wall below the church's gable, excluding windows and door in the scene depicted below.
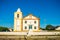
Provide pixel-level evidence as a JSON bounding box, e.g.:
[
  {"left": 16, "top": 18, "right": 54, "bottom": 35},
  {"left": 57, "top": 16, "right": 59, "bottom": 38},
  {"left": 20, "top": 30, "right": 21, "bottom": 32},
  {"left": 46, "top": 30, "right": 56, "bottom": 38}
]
[{"left": 23, "top": 20, "right": 38, "bottom": 30}]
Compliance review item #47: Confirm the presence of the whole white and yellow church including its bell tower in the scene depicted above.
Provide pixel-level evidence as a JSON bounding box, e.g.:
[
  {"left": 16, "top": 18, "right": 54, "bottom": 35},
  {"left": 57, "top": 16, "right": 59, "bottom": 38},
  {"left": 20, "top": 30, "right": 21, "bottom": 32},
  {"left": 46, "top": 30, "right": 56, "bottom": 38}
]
[{"left": 14, "top": 8, "right": 40, "bottom": 32}]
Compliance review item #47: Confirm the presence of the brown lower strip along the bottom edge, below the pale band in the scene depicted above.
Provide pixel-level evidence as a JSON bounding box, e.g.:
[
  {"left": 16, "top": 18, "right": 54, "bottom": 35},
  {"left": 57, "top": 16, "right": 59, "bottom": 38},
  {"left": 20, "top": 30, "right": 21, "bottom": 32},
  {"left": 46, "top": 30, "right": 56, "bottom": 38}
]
[{"left": 0, "top": 35, "right": 60, "bottom": 40}]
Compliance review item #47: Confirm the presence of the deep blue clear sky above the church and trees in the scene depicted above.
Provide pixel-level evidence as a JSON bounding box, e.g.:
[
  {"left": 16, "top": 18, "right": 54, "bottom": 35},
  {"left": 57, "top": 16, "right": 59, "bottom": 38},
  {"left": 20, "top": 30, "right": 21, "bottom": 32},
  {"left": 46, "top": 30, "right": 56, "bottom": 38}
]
[{"left": 0, "top": 0, "right": 60, "bottom": 28}]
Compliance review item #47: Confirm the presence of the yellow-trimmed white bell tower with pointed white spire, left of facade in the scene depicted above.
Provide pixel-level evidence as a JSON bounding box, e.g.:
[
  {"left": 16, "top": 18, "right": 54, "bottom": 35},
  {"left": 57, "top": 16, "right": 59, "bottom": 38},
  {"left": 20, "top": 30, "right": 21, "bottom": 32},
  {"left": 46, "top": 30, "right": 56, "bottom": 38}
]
[{"left": 14, "top": 8, "right": 22, "bottom": 31}]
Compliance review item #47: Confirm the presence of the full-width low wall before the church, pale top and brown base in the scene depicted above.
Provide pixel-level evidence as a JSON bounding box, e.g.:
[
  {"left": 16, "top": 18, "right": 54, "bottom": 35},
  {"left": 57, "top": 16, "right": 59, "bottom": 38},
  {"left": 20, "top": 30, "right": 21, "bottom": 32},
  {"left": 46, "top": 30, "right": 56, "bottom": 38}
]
[{"left": 0, "top": 32, "right": 60, "bottom": 40}]
